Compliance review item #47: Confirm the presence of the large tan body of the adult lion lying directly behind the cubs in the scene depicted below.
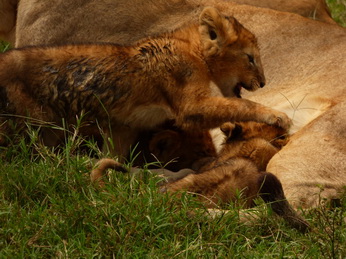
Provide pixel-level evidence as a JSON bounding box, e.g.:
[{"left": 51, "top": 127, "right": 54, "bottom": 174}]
[{"left": 2, "top": 0, "right": 346, "bottom": 207}]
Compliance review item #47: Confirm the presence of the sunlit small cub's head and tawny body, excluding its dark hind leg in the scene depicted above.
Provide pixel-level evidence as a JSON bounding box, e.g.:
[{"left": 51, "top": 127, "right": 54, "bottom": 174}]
[{"left": 167, "top": 122, "right": 287, "bottom": 203}]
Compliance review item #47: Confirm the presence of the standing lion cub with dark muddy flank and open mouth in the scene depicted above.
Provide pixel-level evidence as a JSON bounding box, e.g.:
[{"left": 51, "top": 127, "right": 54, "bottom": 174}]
[{"left": 0, "top": 7, "right": 290, "bottom": 156}]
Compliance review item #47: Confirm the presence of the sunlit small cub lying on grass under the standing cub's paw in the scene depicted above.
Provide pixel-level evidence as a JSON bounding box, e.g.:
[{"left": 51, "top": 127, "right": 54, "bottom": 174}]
[{"left": 162, "top": 122, "right": 309, "bottom": 234}]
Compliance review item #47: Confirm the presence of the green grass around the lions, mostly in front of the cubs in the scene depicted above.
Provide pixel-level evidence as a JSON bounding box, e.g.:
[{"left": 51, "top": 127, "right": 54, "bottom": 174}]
[{"left": 0, "top": 0, "right": 346, "bottom": 258}]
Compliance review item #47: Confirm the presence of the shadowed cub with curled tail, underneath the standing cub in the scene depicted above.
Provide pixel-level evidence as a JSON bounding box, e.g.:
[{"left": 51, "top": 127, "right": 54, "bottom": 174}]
[{"left": 90, "top": 123, "right": 217, "bottom": 187}]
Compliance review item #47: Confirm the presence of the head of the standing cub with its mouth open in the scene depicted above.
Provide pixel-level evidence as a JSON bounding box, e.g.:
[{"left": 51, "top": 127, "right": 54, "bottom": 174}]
[{"left": 199, "top": 7, "right": 265, "bottom": 97}]
